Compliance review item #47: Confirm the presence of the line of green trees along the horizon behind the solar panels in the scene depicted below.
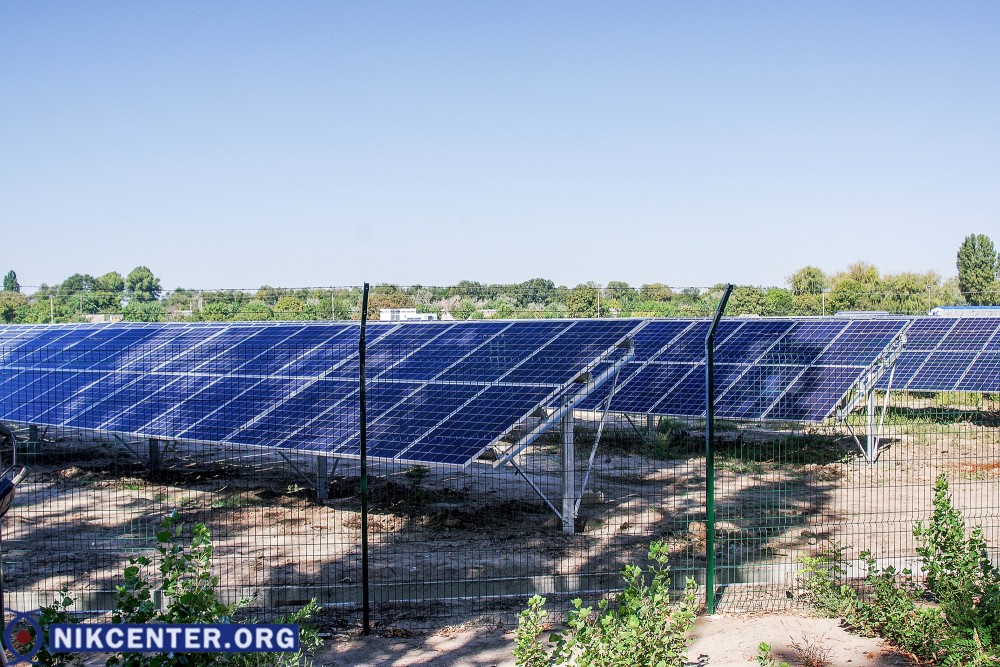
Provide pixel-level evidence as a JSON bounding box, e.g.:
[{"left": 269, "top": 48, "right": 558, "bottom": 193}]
[{"left": 0, "top": 234, "right": 1000, "bottom": 323}]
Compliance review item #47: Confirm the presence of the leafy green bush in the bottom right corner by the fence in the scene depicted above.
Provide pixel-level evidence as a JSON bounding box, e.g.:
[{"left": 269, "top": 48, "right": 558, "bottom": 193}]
[{"left": 803, "top": 475, "right": 1000, "bottom": 667}]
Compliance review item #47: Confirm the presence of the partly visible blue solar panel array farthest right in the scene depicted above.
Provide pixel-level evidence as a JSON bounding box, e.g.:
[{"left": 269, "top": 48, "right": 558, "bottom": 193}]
[{"left": 879, "top": 317, "right": 1000, "bottom": 392}]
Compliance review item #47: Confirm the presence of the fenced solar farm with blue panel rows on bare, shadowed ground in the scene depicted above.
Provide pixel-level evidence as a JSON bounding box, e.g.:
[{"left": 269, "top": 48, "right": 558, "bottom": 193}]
[{"left": 0, "top": 314, "right": 1000, "bottom": 625}]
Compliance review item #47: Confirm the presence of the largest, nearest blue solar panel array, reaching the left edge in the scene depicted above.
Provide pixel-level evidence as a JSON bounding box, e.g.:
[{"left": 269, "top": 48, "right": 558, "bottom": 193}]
[{"left": 0, "top": 320, "right": 642, "bottom": 465}]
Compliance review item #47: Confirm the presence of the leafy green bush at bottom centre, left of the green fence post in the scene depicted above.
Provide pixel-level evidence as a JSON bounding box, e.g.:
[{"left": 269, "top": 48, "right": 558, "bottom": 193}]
[{"left": 514, "top": 542, "right": 697, "bottom": 667}]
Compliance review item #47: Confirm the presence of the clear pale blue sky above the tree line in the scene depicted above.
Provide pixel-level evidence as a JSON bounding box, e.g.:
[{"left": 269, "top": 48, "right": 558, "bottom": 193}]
[{"left": 0, "top": 0, "right": 1000, "bottom": 288}]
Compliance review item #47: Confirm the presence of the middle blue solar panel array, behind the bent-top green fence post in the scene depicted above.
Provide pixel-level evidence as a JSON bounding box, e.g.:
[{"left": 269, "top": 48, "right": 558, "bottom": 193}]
[{"left": 583, "top": 318, "right": 908, "bottom": 422}]
